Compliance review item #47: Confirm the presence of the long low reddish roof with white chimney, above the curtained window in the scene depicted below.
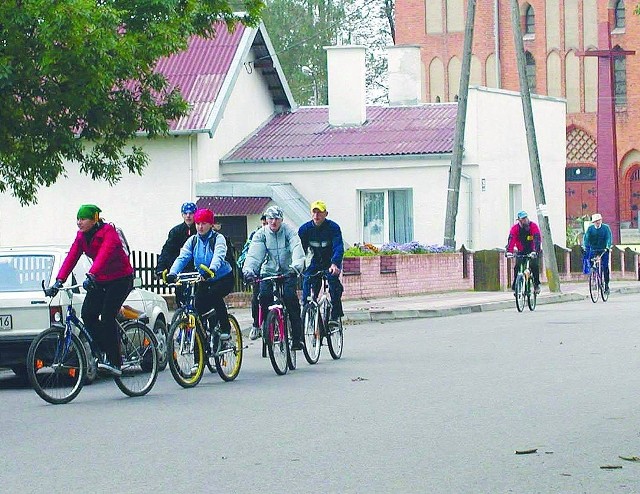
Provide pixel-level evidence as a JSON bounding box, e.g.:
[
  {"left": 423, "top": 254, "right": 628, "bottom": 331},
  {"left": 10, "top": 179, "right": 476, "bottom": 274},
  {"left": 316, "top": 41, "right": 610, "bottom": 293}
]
[{"left": 224, "top": 103, "right": 458, "bottom": 161}]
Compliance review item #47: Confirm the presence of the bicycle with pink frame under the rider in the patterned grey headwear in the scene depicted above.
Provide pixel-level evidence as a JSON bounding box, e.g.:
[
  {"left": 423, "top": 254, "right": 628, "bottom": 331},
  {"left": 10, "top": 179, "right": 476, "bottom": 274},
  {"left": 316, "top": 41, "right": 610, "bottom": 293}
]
[{"left": 256, "top": 274, "right": 297, "bottom": 376}]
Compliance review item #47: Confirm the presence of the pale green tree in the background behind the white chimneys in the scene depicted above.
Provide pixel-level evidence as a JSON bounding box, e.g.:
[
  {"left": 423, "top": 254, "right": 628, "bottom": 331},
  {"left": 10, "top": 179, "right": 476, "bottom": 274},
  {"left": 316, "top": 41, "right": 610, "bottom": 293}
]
[{"left": 263, "top": 0, "right": 395, "bottom": 105}]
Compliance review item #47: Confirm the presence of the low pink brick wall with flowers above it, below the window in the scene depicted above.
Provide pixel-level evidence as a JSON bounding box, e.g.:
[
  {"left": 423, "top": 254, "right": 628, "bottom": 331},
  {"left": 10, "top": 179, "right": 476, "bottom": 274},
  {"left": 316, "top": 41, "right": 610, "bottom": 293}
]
[{"left": 342, "top": 252, "right": 473, "bottom": 299}]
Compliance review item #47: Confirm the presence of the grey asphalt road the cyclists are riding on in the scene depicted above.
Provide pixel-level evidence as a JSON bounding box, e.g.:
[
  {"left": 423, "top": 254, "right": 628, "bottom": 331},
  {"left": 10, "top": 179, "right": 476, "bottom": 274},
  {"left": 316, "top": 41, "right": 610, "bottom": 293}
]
[{"left": 0, "top": 295, "right": 640, "bottom": 493}]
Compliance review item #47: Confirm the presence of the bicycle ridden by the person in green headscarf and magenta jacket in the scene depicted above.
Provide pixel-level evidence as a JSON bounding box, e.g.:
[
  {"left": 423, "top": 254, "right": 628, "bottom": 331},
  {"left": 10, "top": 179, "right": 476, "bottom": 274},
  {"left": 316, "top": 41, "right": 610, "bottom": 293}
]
[{"left": 27, "top": 281, "right": 158, "bottom": 405}]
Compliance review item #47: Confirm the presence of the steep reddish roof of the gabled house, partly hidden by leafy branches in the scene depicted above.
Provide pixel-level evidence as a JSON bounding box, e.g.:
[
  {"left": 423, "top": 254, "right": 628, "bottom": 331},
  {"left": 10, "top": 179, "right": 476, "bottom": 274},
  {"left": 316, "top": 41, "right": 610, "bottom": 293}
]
[{"left": 155, "top": 23, "right": 245, "bottom": 131}]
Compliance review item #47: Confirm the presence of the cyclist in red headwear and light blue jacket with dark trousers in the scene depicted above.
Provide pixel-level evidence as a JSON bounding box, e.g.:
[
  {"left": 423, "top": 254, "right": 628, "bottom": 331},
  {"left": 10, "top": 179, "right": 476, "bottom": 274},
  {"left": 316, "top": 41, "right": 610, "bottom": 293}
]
[{"left": 166, "top": 209, "right": 234, "bottom": 339}]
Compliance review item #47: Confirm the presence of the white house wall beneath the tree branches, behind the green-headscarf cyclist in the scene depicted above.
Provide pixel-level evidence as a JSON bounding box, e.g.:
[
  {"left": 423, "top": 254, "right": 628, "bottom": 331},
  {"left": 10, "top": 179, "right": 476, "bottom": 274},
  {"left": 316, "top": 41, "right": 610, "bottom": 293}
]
[{"left": 0, "top": 136, "right": 192, "bottom": 252}]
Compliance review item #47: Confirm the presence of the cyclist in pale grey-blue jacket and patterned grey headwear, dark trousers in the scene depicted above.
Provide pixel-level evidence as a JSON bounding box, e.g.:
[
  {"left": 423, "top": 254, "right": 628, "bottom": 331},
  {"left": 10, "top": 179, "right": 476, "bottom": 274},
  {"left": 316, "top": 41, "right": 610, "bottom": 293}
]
[{"left": 242, "top": 206, "right": 304, "bottom": 350}]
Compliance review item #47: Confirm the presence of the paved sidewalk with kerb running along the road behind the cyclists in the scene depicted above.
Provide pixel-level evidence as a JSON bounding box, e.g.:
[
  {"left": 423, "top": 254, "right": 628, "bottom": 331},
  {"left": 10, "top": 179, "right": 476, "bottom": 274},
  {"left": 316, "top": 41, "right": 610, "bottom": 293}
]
[{"left": 230, "top": 281, "right": 640, "bottom": 330}]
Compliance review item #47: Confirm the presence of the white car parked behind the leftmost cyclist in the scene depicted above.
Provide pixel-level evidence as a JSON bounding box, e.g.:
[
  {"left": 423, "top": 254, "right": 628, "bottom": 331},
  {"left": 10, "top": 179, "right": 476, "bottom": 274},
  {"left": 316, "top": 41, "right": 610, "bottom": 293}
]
[{"left": 0, "top": 246, "right": 169, "bottom": 375}]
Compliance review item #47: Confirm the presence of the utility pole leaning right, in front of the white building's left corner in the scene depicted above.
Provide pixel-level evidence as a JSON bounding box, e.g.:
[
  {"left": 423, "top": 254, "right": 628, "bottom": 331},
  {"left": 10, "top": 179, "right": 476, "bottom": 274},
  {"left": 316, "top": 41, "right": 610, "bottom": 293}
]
[{"left": 443, "top": 0, "right": 476, "bottom": 249}]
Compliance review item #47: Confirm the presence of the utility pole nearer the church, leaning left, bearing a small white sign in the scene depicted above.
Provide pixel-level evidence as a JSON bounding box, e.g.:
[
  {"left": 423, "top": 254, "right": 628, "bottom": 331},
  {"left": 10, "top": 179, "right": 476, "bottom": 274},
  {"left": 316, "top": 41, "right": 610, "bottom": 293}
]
[{"left": 511, "top": 0, "right": 560, "bottom": 292}]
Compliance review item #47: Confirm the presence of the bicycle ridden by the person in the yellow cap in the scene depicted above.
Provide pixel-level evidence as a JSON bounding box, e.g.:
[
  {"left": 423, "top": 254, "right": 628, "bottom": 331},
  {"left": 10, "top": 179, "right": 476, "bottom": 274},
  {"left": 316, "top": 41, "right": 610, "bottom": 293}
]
[{"left": 302, "top": 270, "right": 344, "bottom": 364}]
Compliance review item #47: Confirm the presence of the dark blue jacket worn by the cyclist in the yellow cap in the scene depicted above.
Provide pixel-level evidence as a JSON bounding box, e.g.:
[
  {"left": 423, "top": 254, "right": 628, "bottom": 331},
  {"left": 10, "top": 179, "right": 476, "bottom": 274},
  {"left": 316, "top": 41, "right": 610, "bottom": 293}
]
[{"left": 298, "top": 219, "right": 344, "bottom": 274}]
